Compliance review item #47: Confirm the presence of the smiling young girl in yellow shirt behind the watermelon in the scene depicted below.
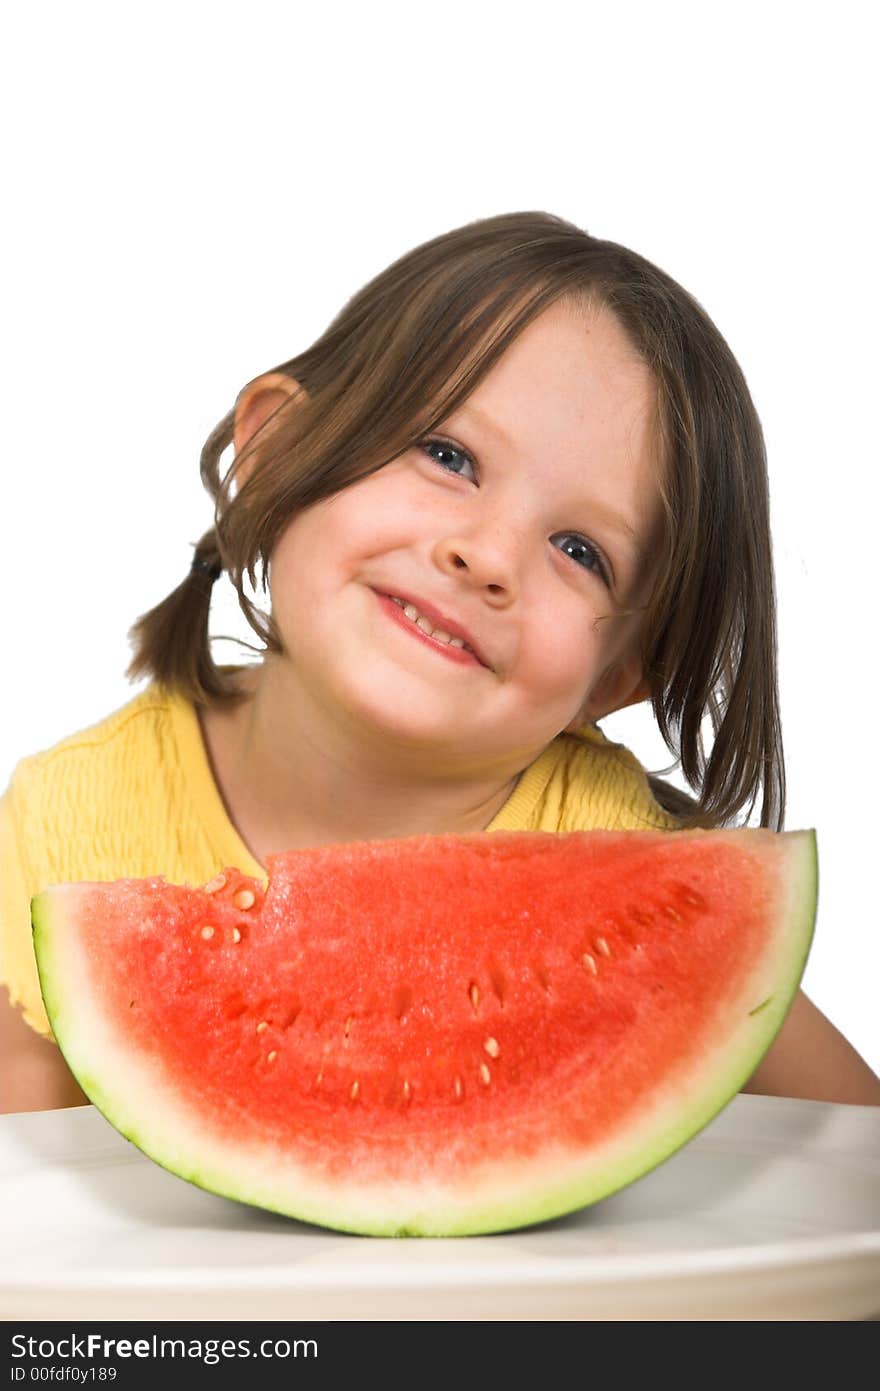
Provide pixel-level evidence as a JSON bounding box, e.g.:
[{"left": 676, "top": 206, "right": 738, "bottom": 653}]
[{"left": 0, "top": 213, "right": 880, "bottom": 1110}]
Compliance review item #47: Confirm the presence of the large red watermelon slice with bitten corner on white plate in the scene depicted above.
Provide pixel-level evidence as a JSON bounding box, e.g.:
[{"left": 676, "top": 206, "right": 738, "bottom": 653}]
[{"left": 32, "top": 830, "right": 817, "bottom": 1235}]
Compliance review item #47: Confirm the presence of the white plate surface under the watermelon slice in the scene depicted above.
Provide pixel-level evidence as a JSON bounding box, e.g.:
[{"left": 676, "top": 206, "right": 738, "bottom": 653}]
[{"left": 0, "top": 1095, "right": 880, "bottom": 1321}]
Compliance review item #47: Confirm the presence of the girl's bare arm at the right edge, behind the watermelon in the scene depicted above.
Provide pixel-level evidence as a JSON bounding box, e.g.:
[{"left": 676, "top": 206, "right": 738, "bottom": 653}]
[{"left": 742, "top": 990, "right": 880, "bottom": 1106}]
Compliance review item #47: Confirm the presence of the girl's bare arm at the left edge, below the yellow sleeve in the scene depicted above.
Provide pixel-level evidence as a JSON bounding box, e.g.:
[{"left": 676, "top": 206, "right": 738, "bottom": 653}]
[{"left": 0, "top": 986, "right": 89, "bottom": 1114}]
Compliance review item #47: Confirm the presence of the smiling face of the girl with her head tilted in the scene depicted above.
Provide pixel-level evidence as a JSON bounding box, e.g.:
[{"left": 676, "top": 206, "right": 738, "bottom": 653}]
[{"left": 257, "top": 303, "right": 660, "bottom": 775}]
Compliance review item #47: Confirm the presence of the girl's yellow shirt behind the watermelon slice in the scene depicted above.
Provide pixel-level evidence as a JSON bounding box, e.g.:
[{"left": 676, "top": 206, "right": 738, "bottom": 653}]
[{"left": 0, "top": 686, "right": 676, "bottom": 1038}]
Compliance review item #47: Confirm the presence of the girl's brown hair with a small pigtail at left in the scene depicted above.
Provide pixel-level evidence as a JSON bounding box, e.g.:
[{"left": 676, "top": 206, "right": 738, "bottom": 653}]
[{"left": 128, "top": 213, "right": 785, "bottom": 829}]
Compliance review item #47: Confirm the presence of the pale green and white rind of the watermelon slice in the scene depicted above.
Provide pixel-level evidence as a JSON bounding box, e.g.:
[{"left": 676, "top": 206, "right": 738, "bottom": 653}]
[{"left": 32, "top": 830, "right": 819, "bottom": 1237}]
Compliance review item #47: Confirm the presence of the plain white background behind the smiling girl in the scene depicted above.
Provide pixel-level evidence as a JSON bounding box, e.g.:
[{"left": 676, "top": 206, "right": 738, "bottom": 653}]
[{"left": 0, "top": 0, "right": 880, "bottom": 1070}]
